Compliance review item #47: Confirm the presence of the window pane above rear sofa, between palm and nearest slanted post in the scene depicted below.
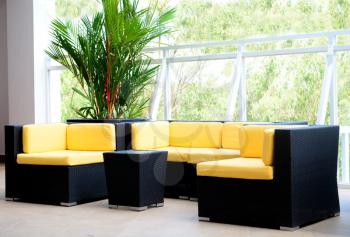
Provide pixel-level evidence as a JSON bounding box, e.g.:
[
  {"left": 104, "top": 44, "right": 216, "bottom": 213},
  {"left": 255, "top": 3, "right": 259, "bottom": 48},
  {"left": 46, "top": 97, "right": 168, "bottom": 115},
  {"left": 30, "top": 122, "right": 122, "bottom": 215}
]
[{"left": 171, "top": 60, "right": 233, "bottom": 120}]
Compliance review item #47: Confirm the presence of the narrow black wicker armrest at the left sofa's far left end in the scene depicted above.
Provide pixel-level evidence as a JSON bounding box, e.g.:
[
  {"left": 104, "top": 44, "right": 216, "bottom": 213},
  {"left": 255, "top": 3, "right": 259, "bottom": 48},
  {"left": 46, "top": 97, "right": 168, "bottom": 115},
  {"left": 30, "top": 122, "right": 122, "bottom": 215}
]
[{"left": 5, "top": 125, "right": 23, "bottom": 198}]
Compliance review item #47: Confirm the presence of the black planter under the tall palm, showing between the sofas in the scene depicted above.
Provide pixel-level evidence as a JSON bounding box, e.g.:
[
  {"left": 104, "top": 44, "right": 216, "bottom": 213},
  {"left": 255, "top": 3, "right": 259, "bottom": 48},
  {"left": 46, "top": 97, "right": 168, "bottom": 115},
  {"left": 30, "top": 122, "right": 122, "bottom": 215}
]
[{"left": 67, "top": 118, "right": 149, "bottom": 151}]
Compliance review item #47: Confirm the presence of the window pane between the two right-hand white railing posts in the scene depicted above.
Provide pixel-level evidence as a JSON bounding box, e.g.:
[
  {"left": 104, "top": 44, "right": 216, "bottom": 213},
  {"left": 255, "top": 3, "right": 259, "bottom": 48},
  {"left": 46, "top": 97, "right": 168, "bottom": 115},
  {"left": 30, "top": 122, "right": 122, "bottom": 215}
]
[{"left": 246, "top": 54, "right": 325, "bottom": 123}]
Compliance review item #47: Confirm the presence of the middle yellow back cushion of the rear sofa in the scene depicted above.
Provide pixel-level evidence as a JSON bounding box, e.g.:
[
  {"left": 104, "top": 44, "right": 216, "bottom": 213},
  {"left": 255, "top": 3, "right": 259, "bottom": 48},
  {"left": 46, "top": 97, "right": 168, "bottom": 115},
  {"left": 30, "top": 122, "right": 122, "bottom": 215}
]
[{"left": 170, "top": 122, "right": 223, "bottom": 148}]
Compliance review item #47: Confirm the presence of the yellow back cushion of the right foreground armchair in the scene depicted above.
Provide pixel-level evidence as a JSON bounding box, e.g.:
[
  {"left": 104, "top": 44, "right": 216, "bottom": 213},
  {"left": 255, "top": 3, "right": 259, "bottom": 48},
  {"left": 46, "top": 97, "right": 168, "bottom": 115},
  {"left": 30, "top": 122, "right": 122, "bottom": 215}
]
[{"left": 239, "top": 125, "right": 286, "bottom": 158}]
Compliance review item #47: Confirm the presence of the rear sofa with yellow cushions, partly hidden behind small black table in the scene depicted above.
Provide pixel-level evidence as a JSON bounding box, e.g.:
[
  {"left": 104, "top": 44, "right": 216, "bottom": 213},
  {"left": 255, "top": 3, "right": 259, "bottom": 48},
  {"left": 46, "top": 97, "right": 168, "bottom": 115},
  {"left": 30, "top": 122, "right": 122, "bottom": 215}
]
[{"left": 131, "top": 121, "right": 244, "bottom": 198}]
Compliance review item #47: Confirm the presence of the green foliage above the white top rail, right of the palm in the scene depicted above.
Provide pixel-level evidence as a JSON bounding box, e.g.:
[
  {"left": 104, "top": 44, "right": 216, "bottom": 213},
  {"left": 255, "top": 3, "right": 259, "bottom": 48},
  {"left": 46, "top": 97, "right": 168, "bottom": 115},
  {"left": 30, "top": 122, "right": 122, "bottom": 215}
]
[{"left": 176, "top": 0, "right": 350, "bottom": 43}]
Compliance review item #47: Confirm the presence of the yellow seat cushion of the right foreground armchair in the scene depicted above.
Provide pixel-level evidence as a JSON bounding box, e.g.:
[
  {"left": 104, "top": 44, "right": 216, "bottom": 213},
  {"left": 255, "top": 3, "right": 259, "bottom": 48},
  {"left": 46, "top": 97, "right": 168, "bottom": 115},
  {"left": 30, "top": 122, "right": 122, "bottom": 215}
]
[{"left": 197, "top": 158, "right": 273, "bottom": 180}]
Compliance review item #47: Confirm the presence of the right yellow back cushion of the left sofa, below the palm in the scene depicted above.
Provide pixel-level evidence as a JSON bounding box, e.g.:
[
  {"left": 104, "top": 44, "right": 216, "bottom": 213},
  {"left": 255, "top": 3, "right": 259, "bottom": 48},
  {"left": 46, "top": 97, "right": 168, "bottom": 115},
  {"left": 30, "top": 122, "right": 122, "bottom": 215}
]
[{"left": 67, "top": 123, "right": 116, "bottom": 151}]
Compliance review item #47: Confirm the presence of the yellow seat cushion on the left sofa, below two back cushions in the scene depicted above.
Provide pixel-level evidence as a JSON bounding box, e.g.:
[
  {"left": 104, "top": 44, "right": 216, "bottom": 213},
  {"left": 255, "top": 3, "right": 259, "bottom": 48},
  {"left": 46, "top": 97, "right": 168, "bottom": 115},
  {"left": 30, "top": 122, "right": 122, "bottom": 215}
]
[{"left": 17, "top": 150, "right": 103, "bottom": 166}]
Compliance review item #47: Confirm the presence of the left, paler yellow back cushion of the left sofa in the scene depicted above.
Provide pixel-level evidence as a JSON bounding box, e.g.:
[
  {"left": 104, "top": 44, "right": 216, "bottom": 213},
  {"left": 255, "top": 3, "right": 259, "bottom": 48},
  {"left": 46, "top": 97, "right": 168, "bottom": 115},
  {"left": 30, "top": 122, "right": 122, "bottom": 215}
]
[{"left": 23, "top": 123, "right": 67, "bottom": 153}]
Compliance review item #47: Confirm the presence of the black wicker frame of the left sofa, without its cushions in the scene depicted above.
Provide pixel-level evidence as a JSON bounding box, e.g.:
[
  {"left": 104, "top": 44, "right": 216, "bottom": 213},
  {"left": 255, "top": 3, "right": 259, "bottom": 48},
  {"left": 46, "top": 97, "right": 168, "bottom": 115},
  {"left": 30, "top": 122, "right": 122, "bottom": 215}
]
[{"left": 5, "top": 126, "right": 107, "bottom": 204}]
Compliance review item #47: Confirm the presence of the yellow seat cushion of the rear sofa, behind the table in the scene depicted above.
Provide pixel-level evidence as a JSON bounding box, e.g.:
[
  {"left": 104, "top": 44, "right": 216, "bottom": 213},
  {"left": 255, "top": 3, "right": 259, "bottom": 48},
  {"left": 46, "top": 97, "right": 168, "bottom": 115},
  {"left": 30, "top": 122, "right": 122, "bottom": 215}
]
[{"left": 154, "top": 147, "right": 239, "bottom": 164}]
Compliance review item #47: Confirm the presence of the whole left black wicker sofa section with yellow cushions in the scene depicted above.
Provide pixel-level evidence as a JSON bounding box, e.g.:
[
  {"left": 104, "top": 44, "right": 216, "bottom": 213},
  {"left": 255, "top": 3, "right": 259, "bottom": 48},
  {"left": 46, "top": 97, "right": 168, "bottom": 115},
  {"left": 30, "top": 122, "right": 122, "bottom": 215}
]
[{"left": 5, "top": 124, "right": 116, "bottom": 206}]
